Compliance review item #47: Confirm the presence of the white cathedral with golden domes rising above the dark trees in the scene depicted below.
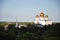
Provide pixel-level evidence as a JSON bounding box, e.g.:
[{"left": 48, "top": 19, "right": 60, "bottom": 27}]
[{"left": 34, "top": 12, "right": 52, "bottom": 26}]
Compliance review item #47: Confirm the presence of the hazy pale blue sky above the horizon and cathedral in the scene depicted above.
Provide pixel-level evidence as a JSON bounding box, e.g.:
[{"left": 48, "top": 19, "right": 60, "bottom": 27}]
[{"left": 0, "top": 0, "right": 60, "bottom": 22}]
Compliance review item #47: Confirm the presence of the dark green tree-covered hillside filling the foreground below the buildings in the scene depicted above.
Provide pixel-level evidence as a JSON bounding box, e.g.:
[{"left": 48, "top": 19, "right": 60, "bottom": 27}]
[{"left": 0, "top": 22, "right": 60, "bottom": 40}]
